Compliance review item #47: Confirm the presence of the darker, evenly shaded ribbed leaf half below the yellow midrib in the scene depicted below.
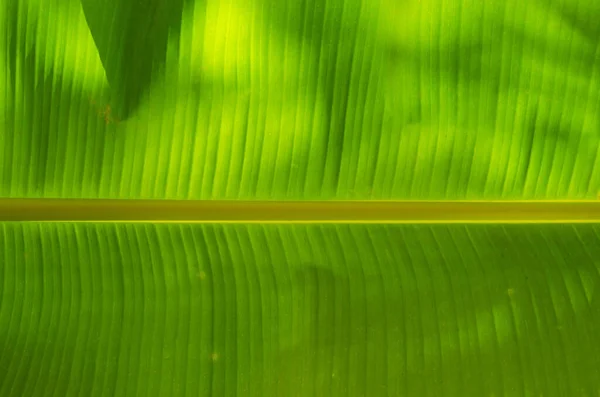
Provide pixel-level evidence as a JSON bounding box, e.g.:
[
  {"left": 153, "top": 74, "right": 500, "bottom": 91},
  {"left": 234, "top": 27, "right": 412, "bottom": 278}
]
[{"left": 0, "top": 223, "right": 600, "bottom": 396}]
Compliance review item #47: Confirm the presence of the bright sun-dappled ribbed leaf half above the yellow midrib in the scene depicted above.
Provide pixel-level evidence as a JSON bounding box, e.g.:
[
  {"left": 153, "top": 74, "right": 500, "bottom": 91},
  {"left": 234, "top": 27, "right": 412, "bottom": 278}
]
[{"left": 0, "top": 0, "right": 600, "bottom": 199}]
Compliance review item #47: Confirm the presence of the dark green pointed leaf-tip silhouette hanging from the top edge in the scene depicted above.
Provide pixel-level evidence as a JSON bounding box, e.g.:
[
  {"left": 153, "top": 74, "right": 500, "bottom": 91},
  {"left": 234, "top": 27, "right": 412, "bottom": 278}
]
[{"left": 81, "top": 0, "right": 186, "bottom": 119}]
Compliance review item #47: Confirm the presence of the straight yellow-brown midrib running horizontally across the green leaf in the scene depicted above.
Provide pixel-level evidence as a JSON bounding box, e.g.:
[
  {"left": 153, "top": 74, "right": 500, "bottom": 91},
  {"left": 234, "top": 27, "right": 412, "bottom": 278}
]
[{"left": 0, "top": 199, "right": 600, "bottom": 223}]
